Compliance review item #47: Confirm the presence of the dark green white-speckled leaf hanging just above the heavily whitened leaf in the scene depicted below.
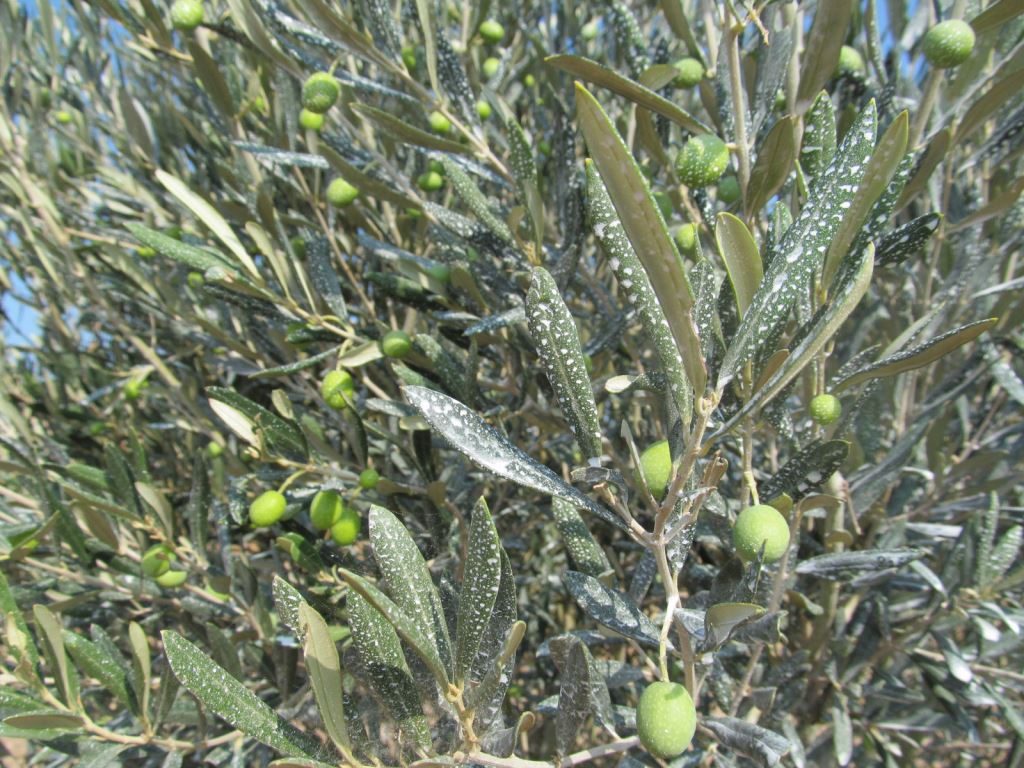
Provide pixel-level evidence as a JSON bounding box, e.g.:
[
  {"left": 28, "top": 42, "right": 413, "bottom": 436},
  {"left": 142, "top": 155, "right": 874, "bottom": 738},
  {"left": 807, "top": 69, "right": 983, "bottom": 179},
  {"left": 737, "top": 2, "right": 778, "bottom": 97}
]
[{"left": 526, "top": 267, "right": 602, "bottom": 459}]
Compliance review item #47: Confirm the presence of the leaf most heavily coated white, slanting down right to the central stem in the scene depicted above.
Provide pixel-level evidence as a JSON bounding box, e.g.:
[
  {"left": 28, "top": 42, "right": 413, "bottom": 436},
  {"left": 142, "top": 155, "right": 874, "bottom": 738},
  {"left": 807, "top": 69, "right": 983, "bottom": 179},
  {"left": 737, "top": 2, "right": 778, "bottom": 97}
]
[{"left": 402, "top": 386, "right": 626, "bottom": 530}]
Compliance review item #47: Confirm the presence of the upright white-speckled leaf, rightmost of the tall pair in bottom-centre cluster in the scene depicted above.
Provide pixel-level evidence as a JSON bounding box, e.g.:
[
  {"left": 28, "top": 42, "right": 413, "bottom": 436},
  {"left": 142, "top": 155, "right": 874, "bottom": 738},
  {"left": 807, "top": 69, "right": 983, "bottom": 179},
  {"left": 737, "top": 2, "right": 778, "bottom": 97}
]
[{"left": 455, "top": 497, "right": 502, "bottom": 685}]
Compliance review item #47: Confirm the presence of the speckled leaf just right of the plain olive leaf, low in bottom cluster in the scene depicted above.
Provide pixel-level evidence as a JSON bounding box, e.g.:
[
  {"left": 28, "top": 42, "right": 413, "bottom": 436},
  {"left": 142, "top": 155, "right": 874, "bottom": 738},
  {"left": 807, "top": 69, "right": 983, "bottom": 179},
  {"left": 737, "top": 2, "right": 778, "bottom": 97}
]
[{"left": 346, "top": 592, "right": 430, "bottom": 749}]
